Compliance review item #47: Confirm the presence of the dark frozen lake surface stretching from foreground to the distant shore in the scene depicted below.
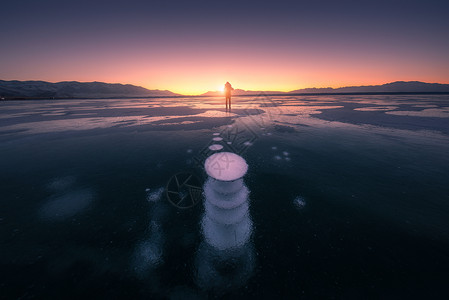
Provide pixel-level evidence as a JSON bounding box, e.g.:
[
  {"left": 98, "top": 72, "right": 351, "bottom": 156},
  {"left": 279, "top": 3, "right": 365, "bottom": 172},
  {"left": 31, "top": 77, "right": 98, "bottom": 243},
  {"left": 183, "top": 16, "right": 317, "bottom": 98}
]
[{"left": 0, "top": 95, "right": 449, "bottom": 299}]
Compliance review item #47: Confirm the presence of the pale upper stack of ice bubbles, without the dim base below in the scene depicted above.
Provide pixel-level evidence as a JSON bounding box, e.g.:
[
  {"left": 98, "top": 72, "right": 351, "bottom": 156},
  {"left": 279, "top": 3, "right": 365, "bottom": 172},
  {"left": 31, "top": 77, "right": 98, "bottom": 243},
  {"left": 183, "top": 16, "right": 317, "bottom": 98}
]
[{"left": 202, "top": 152, "right": 252, "bottom": 250}]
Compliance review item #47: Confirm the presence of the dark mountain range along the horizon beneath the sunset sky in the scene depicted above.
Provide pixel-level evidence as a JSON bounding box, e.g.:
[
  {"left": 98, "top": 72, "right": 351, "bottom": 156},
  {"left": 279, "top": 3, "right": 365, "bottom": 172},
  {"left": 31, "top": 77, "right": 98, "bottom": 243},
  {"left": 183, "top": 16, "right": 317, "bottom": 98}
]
[{"left": 0, "top": 80, "right": 449, "bottom": 99}]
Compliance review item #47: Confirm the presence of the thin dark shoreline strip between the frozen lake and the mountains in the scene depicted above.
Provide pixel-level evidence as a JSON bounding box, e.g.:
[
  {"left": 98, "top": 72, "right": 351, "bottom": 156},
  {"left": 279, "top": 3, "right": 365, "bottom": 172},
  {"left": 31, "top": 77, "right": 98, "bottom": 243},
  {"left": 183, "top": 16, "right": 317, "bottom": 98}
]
[{"left": 0, "top": 92, "right": 449, "bottom": 101}]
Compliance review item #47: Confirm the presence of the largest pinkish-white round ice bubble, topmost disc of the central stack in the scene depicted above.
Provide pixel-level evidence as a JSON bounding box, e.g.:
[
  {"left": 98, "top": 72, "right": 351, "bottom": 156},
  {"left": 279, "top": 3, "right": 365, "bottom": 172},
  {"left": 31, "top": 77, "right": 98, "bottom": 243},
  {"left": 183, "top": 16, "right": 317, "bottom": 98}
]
[{"left": 204, "top": 152, "right": 248, "bottom": 181}]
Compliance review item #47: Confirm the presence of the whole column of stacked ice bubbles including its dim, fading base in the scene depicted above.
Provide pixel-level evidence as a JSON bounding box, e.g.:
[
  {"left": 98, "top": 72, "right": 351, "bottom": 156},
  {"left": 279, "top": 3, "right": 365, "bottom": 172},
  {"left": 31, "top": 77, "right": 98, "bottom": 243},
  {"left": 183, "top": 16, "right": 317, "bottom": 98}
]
[{"left": 195, "top": 152, "right": 255, "bottom": 292}]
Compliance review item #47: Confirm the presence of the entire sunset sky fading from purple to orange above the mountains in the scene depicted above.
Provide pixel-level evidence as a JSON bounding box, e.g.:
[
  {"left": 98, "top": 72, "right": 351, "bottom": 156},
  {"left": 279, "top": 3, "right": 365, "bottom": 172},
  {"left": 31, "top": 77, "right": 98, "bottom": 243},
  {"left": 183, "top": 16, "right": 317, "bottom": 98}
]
[{"left": 0, "top": 0, "right": 449, "bottom": 94}]
